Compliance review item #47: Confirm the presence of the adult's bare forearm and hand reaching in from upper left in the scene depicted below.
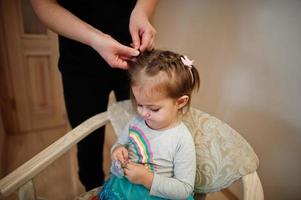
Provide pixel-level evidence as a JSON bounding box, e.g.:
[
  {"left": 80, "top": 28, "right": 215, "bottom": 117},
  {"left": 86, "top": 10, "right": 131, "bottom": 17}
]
[{"left": 31, "top": 0, "right": 139, "bottom": 68}]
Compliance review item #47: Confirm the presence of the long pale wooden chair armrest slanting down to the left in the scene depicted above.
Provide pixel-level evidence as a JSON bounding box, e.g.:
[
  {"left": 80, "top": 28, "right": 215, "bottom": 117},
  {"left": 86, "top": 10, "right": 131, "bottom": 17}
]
[{"left": 0, "top": 112, "right": 109, "bottom": 199}]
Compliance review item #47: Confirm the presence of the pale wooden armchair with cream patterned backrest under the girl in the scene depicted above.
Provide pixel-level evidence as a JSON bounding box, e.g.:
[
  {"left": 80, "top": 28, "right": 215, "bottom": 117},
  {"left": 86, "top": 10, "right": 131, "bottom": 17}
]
[{"left": 0, "top": 101, "right": 264, "bottom": 200}]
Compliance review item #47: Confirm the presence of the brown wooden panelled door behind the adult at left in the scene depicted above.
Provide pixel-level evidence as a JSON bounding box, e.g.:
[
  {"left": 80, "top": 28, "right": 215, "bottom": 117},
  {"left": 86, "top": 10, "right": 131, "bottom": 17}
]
[{"left": 0, "top": 0, "right": 67, "bottom": 133}]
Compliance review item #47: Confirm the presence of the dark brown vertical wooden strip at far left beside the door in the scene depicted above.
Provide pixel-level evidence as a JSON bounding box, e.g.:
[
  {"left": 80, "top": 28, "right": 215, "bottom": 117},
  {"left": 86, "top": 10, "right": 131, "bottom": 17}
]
[{"left": 0, "top": 0, "right": 28, "bottom": 133}]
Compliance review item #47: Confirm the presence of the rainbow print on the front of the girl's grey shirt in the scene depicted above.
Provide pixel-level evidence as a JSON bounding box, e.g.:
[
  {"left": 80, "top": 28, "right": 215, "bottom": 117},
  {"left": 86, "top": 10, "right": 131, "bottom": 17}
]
[{"left": 129, "top": 126, "right": 154, "bottom": 172}]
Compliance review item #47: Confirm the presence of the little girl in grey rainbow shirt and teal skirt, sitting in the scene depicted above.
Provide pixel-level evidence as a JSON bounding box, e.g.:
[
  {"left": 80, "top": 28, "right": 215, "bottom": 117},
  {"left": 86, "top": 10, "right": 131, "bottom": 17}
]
[{"left": 98, "top": 50, "right": 200, "bottom": 200}]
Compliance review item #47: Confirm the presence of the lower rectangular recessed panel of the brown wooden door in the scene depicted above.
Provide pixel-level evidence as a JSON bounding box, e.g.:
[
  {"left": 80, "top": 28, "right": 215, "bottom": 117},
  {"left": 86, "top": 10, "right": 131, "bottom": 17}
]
[{"left": 20, "top": 51, "right": 66, "bottom": 130}]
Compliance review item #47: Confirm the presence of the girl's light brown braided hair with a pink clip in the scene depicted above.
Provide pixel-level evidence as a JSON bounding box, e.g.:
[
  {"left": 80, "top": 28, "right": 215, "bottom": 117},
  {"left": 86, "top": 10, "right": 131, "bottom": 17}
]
[{"left": 128, "top": 49, "right": 200, "bottom": 111}]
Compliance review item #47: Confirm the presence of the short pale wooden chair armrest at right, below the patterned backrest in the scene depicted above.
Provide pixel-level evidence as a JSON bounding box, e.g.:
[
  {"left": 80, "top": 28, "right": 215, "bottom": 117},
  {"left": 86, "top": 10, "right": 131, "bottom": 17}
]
[{"left": 242, "top": 171, "right": 264, "bottom": 200}]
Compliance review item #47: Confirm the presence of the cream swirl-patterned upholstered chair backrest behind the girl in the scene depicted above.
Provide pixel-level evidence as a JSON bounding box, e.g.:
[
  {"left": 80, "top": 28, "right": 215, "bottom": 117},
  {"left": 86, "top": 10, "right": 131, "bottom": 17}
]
[{"left": 108, "top": 100, "right": 259, "bottom": 193}]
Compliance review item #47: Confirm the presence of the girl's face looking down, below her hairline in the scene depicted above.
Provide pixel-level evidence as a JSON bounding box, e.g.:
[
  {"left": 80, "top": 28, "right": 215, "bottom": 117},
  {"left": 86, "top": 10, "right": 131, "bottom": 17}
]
[{"left": 132, "top": 86, "right": 179, "bottom": 130}]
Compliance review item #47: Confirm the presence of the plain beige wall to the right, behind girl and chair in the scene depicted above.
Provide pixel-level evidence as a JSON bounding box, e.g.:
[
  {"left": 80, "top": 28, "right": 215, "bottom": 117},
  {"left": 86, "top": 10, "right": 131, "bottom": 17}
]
[{"left": 154, "top": 0, "right": 301, "bottom": 200}]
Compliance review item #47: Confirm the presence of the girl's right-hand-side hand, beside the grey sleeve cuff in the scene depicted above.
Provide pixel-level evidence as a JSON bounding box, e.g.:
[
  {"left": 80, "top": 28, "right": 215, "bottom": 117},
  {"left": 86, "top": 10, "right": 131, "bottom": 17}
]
[{"left": 124, "top": 161, "right": 154, "bottom": 188}]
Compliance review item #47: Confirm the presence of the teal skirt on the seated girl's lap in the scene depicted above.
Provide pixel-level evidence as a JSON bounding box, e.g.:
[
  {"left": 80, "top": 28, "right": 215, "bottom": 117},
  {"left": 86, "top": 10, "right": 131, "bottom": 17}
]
[{"left": 97, "top": 175, "right": 193, "bottom": 200}]
